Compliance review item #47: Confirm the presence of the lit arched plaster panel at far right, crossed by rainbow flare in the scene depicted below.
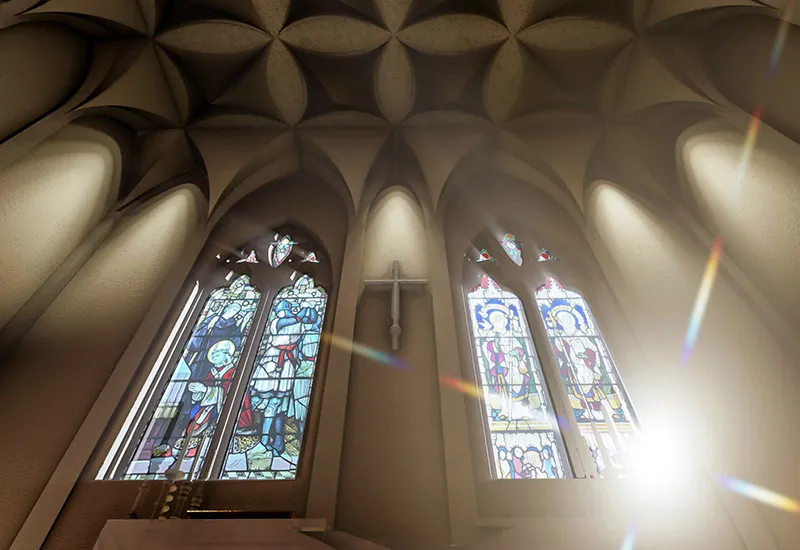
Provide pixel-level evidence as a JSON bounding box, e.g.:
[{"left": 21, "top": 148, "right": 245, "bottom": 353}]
[{"left": 678, "top": 124, "right": 800, "bottom": 334}]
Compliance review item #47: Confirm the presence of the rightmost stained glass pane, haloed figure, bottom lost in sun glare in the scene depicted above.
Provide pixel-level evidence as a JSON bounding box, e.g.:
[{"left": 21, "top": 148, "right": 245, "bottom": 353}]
[{"left": 535, "top": 277, "right": 635, "bottom": 474}]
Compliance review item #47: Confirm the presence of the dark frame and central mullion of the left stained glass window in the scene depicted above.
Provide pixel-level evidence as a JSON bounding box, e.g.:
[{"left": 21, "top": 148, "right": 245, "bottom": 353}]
[{"left": 99, "top": 245, "right": 334, "bottom": 482}]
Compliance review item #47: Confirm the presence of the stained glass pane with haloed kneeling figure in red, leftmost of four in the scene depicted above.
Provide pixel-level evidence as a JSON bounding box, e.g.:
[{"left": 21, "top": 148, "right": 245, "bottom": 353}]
[{"left": 123, "top": 275, "right": 261, "bottom": 479}]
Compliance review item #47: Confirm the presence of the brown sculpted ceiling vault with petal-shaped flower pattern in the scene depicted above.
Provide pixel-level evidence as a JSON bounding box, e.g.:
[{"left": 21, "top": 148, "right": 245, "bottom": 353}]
[{"left": 0, "top": 0, "right": 782, "bottom": 220}]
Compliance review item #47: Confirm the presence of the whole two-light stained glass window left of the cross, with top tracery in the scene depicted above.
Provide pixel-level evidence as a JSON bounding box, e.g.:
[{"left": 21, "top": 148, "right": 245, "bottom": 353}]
[{"left": 98, "top": 235, "right": 328, "bottom": 479}]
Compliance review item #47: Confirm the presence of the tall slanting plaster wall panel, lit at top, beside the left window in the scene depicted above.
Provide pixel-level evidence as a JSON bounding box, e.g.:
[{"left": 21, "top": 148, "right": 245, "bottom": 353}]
[{"left": 0, "top": 186, "right": 202, "bottom": 546}]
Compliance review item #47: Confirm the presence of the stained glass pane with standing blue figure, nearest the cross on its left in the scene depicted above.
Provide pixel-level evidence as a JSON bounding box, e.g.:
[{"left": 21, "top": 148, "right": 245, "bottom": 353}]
[{"left": 222, "top": 275, "right": 328, "bottom": 479}]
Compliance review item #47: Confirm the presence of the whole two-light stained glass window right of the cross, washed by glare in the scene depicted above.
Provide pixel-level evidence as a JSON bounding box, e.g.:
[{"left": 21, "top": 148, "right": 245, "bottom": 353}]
[{"left": 465, "top": 242, "right": 638, "bottom": 479}]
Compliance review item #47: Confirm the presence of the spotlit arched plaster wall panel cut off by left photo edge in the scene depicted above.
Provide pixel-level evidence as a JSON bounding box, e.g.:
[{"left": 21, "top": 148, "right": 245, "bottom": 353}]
[{"left": 0, "top": 127, "right": 120, "bottom": 328}]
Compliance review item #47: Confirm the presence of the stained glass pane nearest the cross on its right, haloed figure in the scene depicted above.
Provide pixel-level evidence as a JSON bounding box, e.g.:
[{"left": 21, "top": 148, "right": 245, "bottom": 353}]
[{"left": 467, "top": 276, "right": 569, "bottom": 479}]
